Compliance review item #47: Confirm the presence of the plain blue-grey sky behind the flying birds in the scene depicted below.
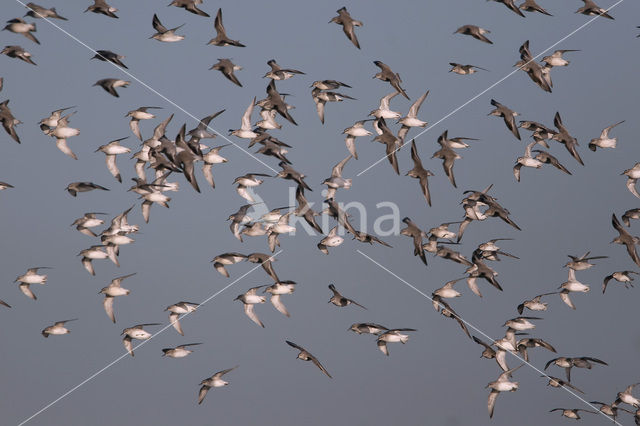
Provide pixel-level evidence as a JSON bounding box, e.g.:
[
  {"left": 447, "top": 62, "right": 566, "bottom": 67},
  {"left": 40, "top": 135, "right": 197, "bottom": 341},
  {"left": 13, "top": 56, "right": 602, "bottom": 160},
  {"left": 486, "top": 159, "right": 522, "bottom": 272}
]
[{"left": 0, "top": 0, "right": 640, "bottom": 426}]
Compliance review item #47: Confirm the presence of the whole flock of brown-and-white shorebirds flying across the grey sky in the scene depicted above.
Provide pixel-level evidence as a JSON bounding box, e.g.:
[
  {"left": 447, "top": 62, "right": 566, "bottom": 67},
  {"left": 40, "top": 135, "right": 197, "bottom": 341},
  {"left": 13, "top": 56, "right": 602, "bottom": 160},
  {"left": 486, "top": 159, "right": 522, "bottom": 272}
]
[{"left": 0, "top": 0, "right": 640, "bottom": 425}]
